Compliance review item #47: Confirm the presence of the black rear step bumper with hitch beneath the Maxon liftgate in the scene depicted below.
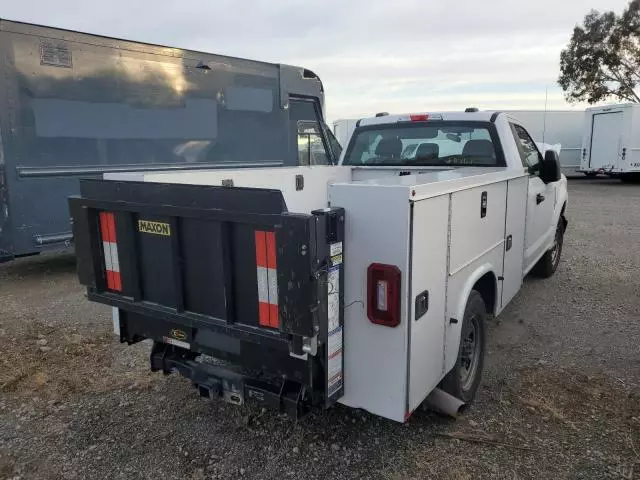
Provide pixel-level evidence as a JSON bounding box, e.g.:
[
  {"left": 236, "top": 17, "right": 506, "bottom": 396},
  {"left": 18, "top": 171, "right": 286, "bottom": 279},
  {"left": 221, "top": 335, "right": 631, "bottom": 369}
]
[{"left": 150, "top": 342, "right": 312, "bottom": 418}]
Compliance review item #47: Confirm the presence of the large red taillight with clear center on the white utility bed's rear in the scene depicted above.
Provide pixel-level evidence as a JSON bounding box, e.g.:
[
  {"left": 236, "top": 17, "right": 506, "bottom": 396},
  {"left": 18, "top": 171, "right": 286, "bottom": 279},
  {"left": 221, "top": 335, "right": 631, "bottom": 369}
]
[{"left": 367, "top": 263, "right": 402, "bottom": 327}]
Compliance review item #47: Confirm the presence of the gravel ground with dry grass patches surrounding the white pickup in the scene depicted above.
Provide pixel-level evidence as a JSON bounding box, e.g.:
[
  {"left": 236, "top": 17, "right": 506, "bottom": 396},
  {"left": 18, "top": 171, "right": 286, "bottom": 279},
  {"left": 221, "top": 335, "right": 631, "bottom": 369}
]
[{"left": 0, "top": 180, "right": 640, "bottom": 480}]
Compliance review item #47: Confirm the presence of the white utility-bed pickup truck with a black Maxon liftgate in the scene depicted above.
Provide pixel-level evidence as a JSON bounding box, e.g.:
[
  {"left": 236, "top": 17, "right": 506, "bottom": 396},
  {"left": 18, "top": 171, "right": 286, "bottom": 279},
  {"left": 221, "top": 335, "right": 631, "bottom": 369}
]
[{"left": 70, "top": 111, "right": 567, "bottom": 422}]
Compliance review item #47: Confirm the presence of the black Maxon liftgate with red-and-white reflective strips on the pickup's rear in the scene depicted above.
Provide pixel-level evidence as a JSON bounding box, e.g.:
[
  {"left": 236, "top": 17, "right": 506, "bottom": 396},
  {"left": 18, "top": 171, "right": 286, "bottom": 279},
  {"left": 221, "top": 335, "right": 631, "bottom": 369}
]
[{"left": 69, "top": 180, "right": 345, "bottom": 415}]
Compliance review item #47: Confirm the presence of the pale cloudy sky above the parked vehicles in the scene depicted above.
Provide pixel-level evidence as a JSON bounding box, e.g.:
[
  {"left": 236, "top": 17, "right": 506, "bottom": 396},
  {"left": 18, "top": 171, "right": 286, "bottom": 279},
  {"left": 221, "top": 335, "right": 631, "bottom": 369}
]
[{"left": 0, "top": 0, "right": 627, "bottom": 120}]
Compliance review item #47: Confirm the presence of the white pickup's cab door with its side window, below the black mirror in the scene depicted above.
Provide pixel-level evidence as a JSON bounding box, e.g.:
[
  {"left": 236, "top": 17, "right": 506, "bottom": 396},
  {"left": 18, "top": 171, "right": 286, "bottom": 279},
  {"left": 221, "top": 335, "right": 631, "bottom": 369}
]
[{"left": 511, "top": 123, "right": 555, "bottom": 272}]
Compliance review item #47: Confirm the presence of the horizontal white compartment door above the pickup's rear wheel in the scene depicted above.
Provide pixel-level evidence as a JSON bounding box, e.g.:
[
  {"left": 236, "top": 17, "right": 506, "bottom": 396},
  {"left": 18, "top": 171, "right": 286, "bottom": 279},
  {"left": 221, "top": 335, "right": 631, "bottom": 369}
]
[{"left": 449, "top": 182, "right": 507, "bottom": 275}]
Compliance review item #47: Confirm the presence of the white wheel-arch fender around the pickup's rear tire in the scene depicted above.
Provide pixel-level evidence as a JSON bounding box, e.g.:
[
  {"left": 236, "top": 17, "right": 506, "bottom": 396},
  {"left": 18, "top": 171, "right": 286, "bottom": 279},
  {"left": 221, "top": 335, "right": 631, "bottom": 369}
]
[{"left": 444, "top": 263, "right": 499, "bottom": 374}]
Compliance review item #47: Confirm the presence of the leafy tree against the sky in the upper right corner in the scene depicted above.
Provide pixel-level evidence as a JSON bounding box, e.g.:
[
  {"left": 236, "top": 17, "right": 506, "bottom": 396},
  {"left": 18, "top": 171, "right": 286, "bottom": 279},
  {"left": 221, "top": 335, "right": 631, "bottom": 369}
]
[{"left": 558, "top": 0, "right": 640, "bottom": 103}]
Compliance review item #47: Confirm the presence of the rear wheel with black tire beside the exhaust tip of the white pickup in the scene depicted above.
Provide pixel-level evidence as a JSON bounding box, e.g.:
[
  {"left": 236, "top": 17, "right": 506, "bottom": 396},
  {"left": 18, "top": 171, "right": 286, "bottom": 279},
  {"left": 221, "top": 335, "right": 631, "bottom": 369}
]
[{"left": 441, "top": 290, "right": 487, "bottom": 403}]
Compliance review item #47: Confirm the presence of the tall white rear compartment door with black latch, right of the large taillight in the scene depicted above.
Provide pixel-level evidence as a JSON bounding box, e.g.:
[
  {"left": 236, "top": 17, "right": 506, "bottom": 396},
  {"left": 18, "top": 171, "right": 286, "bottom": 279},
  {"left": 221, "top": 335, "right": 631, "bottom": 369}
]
[{"left": 408, "top": 195, "right": 450, "bottom": 412}]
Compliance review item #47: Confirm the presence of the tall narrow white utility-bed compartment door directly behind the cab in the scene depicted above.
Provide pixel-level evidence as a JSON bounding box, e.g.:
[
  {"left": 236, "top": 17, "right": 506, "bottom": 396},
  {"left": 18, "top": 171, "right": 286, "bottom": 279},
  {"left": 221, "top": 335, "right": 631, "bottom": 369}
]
[{"left": 500, "top": 177, "right": 529, "bottom": 309}]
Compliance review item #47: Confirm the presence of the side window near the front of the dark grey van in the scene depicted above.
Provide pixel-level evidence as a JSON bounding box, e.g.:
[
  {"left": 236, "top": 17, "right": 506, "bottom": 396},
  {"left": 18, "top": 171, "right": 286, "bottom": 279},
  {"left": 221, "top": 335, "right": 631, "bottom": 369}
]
[{"left": 289, "top": 100, "right": 331, "bottom": 165}]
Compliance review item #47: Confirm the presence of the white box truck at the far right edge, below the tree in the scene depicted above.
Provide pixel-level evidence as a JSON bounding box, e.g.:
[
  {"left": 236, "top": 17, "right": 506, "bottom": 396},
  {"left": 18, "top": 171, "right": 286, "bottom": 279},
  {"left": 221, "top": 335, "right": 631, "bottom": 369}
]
[{"left": 580, "top": 103, "right": 640, "bottom": 181}]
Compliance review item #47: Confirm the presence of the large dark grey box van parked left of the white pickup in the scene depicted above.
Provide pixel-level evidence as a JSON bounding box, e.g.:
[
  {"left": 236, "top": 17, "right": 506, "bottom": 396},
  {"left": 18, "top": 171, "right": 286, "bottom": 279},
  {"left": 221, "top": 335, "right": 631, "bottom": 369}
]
[{"left": 0, "top": 19, "right": 338, "bottom": 262}]
